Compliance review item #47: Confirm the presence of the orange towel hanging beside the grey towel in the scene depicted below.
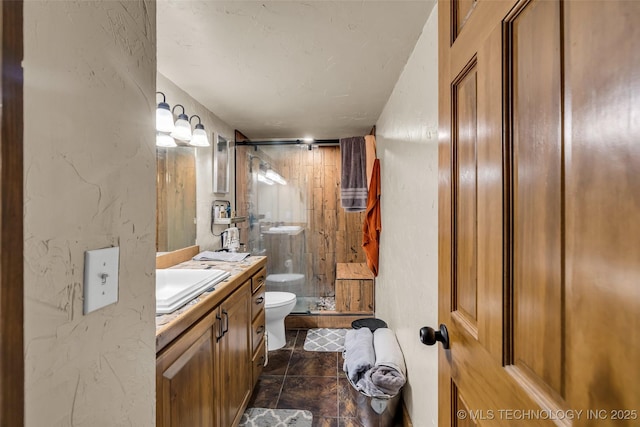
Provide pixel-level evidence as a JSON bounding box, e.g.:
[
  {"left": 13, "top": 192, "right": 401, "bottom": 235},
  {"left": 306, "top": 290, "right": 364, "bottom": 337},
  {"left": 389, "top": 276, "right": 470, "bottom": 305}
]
[{"left": 362, "top": 159, "right": 382, "bottom": 276}]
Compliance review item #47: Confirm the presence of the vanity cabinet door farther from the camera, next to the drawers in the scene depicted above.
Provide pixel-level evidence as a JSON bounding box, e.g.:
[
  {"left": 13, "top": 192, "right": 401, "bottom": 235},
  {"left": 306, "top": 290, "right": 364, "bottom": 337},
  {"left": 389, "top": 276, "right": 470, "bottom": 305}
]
[{"left": 218, "top": 280, "right": 252, "bottom": 427}]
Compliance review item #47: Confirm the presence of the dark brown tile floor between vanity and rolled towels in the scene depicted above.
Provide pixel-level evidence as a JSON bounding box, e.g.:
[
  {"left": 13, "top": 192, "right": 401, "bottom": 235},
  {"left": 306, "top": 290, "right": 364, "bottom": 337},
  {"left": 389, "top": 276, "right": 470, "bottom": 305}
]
[{"left": 249, "top": 329, "right": 402, "bottom": 427}]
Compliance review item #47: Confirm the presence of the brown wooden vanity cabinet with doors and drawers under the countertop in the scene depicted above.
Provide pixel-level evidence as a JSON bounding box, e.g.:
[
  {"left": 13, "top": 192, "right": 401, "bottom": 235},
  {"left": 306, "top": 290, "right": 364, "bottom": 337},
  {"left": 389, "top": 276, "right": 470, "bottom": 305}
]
[{"left": 156, "top": 260, "right": 265, "bottom": 427}]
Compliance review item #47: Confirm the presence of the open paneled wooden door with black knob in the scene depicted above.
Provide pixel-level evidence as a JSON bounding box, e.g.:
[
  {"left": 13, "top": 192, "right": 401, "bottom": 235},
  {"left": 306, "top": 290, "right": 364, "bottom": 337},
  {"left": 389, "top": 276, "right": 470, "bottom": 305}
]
[{"left": 438, "top": 0, "right": 640, "bottom": 426}]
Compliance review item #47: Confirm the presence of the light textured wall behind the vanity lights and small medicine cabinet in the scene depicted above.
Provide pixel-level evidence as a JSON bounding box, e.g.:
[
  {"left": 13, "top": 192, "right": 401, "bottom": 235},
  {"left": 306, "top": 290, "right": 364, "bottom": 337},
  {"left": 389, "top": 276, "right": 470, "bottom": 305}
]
[{"left": 157, "top": 73, "right": 236, "bottom": 250}]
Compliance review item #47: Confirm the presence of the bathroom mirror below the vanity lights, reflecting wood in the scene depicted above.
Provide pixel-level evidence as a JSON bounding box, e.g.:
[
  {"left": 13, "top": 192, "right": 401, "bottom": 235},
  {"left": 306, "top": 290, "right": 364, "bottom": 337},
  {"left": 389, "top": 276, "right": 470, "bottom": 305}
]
[{"left": 156, "top": 146, "right": 196, "bottom": 252}]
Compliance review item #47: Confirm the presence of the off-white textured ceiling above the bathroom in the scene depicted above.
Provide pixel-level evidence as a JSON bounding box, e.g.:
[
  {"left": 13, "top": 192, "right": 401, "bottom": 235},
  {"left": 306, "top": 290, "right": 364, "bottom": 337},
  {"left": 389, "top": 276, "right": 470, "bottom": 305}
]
[{"left": 157, "top": 0, "right": 435, "bottom": 140}]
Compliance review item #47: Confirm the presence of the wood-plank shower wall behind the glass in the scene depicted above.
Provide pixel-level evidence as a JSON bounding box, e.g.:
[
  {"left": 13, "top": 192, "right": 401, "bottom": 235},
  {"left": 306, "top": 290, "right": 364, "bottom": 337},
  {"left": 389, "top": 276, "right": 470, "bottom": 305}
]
[{"left": 234, "top": 137, "right": 365, "bottom": 314}]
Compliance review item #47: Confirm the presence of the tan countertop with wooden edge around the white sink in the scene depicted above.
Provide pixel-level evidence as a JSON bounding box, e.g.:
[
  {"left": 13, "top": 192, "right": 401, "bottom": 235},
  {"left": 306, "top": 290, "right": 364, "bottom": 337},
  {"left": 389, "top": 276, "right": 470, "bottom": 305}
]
[{"left": 156, "top": 256, "right": 267, "bottom": 353}]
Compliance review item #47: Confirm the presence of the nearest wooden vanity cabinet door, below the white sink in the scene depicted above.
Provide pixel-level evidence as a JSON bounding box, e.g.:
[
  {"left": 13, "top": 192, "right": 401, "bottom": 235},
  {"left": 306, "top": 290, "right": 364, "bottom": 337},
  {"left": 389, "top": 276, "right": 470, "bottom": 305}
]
[{"left": 156, "top": 312, "right": 220, "bottom": 427}]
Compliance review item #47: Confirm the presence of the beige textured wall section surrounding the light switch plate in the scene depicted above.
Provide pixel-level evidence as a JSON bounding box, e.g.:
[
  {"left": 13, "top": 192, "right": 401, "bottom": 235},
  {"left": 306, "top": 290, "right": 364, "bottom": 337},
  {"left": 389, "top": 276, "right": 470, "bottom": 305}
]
[{"left": 24, "top": 1, "right": 156, "bottom": 427}]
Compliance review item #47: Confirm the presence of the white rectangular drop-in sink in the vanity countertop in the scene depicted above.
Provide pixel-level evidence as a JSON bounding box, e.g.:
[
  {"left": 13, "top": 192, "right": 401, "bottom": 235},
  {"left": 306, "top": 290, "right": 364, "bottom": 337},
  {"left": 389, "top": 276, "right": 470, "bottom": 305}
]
[{"left": 156, "top": 268, "right": 229, "bottom": 314}]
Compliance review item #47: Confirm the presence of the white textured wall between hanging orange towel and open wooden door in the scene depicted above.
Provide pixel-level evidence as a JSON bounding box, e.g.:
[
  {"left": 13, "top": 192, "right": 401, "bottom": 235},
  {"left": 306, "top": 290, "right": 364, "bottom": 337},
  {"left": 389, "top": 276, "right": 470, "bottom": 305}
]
[{"left": 376, "top": 7, "right": 438, "bottom": 427}]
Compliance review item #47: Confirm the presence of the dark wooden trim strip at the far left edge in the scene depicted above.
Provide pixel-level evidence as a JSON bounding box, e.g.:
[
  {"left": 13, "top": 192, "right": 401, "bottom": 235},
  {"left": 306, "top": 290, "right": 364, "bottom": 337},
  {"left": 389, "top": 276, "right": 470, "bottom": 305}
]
[{"left": 0, "top": 0, "right": 24, "bottom": 426}]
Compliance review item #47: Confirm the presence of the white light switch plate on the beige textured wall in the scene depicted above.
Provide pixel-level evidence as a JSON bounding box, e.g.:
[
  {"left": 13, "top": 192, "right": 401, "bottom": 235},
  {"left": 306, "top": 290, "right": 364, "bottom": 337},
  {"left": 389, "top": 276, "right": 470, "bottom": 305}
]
[{"left": 83, "top": 247, "right": 120, "bottom": 314}]
